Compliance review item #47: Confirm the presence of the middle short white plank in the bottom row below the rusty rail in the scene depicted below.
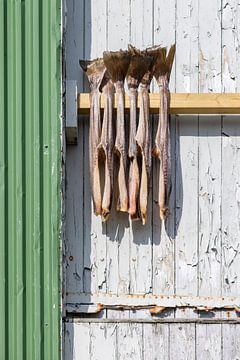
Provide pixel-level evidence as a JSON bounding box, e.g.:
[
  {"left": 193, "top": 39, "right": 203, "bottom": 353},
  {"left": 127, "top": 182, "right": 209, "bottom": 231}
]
[{"left": 143, "top": 324, "right": 169, "bottom": 360}]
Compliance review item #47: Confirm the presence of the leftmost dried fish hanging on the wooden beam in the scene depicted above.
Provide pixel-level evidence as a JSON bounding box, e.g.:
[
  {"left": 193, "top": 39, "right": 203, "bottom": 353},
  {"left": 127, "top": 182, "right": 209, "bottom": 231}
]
[{"left": 79, "top": 59, "right": 106, "bottom": 215}]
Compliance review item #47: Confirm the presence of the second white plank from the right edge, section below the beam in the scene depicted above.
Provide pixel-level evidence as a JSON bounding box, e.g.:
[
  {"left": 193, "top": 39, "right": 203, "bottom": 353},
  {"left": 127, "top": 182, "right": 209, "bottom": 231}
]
[{"left": 199, "top": 117, "right": 221, "bottom": 296}]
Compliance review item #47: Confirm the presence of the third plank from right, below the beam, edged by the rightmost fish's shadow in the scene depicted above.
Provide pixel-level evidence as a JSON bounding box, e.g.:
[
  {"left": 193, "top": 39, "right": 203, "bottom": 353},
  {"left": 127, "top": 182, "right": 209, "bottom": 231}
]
[{"left": 175, "top": 117, "right": 198, "bottom": 296}]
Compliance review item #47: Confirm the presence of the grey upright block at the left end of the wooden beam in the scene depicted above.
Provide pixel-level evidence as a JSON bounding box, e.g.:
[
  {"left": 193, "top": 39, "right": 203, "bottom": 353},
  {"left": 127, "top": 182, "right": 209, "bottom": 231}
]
[{"left": 66, "top": 80, "right": 78, "bottom": 144}]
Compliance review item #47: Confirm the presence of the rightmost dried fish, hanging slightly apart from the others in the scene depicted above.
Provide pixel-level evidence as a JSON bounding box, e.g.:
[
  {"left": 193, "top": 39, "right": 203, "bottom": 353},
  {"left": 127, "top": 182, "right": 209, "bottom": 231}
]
[{"left": 153, "top": 45, "right": 175, "bottom": 220}]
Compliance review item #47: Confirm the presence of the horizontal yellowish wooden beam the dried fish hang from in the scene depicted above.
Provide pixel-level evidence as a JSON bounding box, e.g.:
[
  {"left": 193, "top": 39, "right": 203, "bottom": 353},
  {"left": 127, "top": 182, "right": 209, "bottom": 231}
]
[{"left": 78, "top": 93, "right": 240, "bottom": 115}]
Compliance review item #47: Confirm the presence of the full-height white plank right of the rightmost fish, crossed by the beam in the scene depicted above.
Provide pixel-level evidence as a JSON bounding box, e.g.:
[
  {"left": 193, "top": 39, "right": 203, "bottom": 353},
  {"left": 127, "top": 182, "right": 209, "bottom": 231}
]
[{"left": 175, "top": 0, "right": 198, "bottom": 318}]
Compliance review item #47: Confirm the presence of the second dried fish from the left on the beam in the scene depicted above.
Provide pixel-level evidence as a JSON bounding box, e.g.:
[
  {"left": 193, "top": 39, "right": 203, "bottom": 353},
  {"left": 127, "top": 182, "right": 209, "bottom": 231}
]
[{"left": 99, "top": 71, "right": 114, "bottom": 221}]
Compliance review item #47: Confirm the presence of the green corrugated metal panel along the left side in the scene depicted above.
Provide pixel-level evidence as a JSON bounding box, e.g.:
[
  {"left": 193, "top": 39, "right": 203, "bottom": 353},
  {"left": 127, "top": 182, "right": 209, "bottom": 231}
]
[{"left": 0, "top": 0, "right": 60, "bottom": 360}]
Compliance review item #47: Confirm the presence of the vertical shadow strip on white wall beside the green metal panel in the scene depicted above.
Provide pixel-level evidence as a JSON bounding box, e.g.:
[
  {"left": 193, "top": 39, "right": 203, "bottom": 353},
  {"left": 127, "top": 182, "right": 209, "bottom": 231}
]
[{"left": 63, "top": 0, "right": 92, "bottom": 360}]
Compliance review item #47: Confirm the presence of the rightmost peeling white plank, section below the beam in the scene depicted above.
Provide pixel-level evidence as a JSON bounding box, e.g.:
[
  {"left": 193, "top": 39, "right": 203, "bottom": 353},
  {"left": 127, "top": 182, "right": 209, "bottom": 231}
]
[{"left": 222, "top": 117, "right": 240, "bottom": 296}]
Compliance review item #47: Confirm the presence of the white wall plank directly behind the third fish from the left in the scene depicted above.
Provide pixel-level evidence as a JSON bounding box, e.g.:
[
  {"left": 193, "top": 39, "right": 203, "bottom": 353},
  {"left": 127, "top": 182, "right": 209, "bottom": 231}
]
[{"left": 107, "top": 0, "right": 130, "bottom": 317}]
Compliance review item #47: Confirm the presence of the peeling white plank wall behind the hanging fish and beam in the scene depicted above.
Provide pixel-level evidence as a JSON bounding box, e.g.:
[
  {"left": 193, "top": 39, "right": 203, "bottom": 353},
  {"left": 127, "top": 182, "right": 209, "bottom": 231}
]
[{"left": 64, "top": 0, "right": 240, "bottom": 360}]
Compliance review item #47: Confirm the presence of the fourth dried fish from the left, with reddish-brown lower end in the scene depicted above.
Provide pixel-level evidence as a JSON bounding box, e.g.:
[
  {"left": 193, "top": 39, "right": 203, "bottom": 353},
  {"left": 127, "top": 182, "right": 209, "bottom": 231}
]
[{"left": 127, "top": 45, "right": 152, "bottom": 219}]
